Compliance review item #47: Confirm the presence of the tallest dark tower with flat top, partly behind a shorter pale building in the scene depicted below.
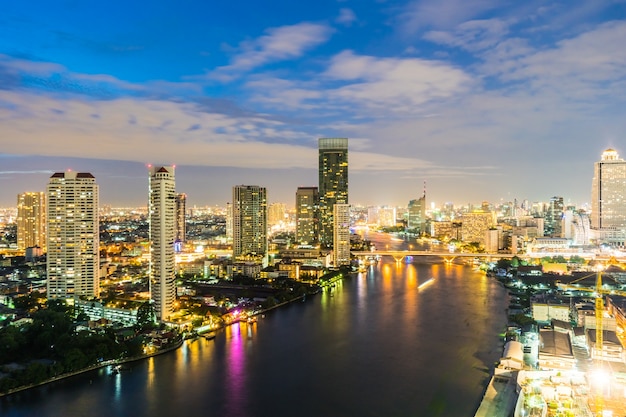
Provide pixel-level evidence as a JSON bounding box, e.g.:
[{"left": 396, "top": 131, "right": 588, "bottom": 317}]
[{"left": 318, "top": 138, "right": 348, "bottom": 247}]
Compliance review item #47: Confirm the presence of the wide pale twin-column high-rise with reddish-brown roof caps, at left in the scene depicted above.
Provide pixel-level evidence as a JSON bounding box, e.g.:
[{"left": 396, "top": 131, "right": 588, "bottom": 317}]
[{"left": 46, "top": 171, "right": 100, "bottom": 299}]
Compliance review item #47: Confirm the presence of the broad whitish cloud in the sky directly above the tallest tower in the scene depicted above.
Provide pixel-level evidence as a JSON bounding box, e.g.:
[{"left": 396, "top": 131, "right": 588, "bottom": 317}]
[{"left": 248, "top": 51, "right": 474, "bottom": 118}]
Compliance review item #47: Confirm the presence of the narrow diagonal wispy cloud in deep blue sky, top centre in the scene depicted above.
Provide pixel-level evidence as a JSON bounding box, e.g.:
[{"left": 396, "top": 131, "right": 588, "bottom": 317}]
[{"left": 209, "top": 22, "right": 333, "bottom": 81}]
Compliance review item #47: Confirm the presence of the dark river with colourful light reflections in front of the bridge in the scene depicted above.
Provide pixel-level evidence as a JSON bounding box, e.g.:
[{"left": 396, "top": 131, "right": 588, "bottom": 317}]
[{"left": 0, "top": 232, "right": 508, "bottom": 417}]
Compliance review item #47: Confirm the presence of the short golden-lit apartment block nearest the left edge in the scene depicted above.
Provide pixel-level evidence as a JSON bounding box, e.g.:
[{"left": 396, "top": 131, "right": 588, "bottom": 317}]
[{"left": 17, "top": 192, "right": 46, "bottom": 252}]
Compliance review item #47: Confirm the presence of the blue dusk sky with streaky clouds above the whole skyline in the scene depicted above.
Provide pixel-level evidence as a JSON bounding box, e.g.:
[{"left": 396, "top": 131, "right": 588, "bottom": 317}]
[{"left": 0, "top": 0, "right": 626, "bottom": 207}]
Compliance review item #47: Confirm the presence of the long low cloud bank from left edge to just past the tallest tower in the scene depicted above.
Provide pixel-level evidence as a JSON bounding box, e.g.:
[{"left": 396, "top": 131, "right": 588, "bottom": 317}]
[{"left": 0, "top": 91, "right": 438, "bottom": 170}]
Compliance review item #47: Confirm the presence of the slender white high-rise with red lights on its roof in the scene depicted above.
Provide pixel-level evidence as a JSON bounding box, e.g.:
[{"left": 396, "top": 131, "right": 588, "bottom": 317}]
[{"left": 149, "top": 166, "right": 177, "bottom": 321}]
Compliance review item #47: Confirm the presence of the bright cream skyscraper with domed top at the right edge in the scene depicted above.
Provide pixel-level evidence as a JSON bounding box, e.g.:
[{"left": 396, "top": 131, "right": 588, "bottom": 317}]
[{"left": 590, "top": 149, "right": 626, "bottom": 247}]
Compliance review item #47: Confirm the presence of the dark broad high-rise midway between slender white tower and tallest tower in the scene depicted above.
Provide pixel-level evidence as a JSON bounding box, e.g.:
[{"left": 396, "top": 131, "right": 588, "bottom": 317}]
[{"left": 232, "top": 185, "right": 267, "bottom": 258}]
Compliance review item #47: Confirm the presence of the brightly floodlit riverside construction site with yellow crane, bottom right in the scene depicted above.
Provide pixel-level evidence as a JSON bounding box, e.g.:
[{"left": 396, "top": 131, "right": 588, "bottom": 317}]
[{"left": 476, "top": 271, "right": 626, "bottom": 417}]
